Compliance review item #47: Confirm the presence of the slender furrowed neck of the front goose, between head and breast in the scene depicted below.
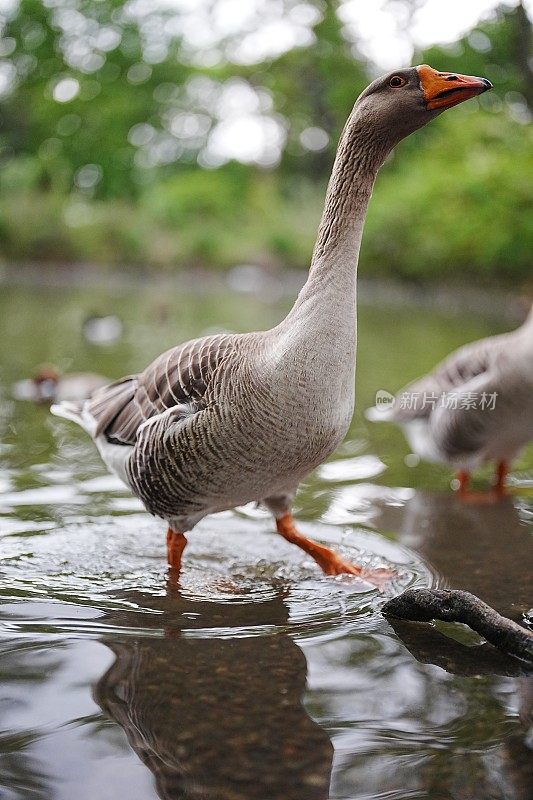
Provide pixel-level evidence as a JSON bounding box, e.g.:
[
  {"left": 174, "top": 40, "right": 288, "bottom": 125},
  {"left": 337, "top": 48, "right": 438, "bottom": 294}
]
[{"left": 286, "top": 109, "right": 390, "bottom": 328}]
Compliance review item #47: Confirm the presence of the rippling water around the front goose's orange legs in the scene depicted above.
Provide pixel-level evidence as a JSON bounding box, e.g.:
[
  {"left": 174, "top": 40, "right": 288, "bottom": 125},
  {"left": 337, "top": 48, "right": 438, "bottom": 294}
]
[{"left": 1, "top": 514, "right": 435, "bottom": 638}]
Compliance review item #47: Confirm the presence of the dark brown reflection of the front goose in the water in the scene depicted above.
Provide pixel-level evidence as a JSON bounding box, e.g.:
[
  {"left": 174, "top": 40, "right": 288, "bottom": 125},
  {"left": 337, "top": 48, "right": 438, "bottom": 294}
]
[{"left": 95, "top": 585, "right": 332, "bottom": 800}]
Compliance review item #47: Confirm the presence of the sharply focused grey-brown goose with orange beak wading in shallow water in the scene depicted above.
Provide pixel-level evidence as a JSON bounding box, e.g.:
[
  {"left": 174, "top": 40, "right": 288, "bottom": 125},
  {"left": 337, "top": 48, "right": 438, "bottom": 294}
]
[{"left": 52, "top": 65, "right": 491, "bottom": 580}]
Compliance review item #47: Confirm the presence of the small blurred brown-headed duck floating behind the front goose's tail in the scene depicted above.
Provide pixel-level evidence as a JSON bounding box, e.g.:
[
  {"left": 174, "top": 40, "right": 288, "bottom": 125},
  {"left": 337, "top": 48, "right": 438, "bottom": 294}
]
[{"left": 12, "top": 364, "right": 109, "bottom": 404}]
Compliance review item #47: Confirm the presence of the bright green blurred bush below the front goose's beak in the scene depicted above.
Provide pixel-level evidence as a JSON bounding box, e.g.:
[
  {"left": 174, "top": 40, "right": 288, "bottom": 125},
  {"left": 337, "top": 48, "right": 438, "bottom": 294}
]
[{"left": 363, "top": 106, "right": 533, "bottom": 282}]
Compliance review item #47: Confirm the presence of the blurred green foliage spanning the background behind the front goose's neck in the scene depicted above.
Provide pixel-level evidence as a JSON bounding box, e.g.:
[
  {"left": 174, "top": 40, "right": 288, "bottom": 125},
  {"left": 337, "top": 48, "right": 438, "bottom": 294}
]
[{"left": 0, "top": 0, "right": 533, "bottom": 281}]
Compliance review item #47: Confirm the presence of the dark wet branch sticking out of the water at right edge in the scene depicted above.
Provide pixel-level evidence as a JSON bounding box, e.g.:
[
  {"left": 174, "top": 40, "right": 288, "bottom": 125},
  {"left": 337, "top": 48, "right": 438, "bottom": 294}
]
[{"left": 382, "top": 589, "right": 533, "bottom": 662}]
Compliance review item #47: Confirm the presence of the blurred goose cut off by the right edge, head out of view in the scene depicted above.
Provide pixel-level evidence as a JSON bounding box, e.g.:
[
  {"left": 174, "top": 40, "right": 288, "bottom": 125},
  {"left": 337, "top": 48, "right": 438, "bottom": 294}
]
[{"left": 366, "top": 307, "right": 533, "bottom": 499}]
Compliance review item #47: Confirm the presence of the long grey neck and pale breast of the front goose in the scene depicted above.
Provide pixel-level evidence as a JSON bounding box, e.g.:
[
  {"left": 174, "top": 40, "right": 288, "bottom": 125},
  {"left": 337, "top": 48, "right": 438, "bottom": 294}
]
[{"left": 273, "top": 108, "right": 390, "bottom": 412}]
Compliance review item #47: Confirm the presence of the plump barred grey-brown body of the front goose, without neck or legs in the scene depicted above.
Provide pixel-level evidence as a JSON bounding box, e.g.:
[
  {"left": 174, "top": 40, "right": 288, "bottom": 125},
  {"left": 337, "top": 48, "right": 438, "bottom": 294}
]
[{"left": 57, "top": 304, "right": 355, "bottom": 532}]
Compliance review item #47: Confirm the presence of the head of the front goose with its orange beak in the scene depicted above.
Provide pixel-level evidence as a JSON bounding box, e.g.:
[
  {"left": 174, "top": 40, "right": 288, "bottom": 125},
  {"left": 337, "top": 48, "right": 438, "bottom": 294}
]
[{"left": 354, "top": 64, "right": 492, "bottom": 145}]
